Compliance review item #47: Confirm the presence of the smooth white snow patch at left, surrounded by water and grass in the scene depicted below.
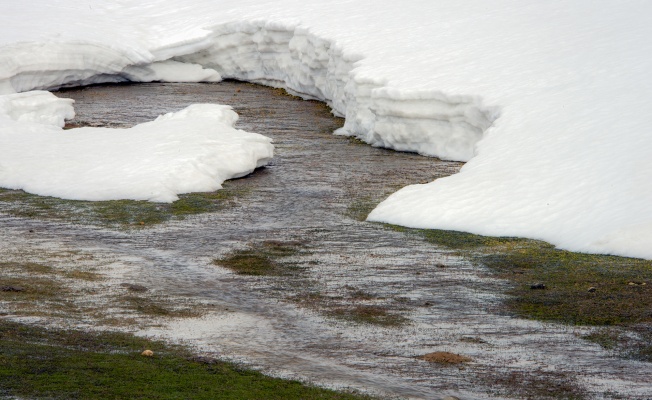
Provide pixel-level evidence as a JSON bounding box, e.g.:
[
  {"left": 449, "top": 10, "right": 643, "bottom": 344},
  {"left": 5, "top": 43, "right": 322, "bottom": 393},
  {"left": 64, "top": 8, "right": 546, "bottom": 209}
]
[{"left": 0, "top": 92, "right": 273, "bottom": 202}]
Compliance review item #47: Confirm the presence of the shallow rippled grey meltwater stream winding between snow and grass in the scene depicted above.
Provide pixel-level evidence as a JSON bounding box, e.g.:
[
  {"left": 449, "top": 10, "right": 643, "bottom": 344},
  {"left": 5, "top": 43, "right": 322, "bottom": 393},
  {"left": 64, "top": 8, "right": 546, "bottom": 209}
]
[{"left": 0, "top": 82, "right": 652, "bottom": 399}]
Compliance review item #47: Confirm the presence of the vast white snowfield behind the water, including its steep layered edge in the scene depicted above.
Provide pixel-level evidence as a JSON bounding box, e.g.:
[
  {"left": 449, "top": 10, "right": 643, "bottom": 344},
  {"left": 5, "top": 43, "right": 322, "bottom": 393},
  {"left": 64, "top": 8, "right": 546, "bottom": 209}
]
[{"left": 0, "top": 0, "right": 652, "bottom": 258}]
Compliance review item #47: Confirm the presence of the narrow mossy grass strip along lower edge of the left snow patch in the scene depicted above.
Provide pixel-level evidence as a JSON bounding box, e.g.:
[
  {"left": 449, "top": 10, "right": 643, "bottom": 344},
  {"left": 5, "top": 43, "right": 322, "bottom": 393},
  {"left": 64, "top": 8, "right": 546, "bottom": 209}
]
[{"left": 0, "top": 182, "right": 248, "bottom": 226}]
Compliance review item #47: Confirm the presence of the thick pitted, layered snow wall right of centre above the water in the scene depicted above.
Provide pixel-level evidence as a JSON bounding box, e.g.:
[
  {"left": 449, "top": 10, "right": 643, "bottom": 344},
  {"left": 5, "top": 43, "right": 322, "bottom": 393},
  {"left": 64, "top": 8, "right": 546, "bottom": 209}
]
[{"left": 173, "top": 21, "right": 497, "bottom": 161}]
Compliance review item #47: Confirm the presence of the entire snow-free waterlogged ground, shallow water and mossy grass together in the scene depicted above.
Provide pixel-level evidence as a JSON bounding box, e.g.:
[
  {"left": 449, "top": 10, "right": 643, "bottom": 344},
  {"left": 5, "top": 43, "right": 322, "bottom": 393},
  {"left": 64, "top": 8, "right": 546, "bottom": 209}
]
[{"left": 0, "top": 82, "right": 652, "bottom": 399}]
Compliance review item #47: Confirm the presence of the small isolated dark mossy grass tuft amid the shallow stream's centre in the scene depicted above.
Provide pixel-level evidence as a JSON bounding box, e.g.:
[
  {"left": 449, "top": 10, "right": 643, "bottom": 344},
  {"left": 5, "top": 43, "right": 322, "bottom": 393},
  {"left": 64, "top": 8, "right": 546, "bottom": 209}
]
[{"left": 214, "top": 240, "right": 301, "bottom": 276}]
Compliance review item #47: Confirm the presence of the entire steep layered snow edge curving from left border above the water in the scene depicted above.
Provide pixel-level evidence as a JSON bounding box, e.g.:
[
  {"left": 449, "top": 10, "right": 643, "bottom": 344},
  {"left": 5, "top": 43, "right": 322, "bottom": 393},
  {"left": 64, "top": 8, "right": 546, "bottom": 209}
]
[{"left": 0, "top": 20, "right": 498, "bottom": 161}]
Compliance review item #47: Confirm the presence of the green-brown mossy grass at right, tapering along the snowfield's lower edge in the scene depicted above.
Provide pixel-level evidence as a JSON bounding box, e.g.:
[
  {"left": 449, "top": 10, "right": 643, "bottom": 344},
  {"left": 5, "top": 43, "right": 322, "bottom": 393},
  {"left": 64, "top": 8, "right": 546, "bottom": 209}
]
[{"left": 387, "top": 225, "right": 652, "bottom": 361}]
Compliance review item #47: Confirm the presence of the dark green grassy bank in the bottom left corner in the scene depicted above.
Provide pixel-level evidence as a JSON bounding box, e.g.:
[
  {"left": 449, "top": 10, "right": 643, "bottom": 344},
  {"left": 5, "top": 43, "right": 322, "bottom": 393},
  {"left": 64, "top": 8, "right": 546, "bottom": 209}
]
[{"left": 0, "top": 321, "right": 364, "bottom": 399}]
